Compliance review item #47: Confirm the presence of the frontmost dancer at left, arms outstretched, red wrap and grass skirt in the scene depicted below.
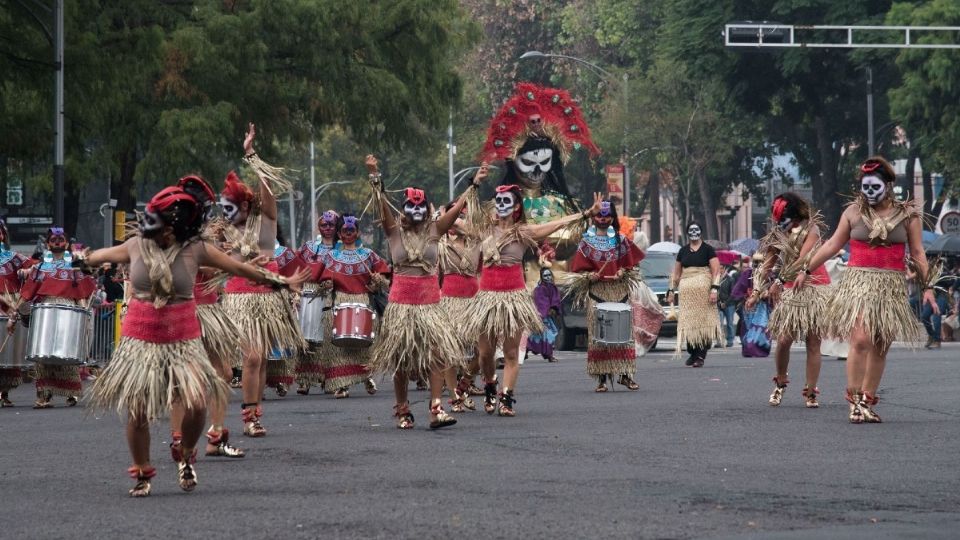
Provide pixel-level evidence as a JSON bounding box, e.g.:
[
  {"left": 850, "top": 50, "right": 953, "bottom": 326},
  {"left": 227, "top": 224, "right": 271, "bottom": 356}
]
[{"left": 82, "top": 187, "right": 306, "bottom": 497}]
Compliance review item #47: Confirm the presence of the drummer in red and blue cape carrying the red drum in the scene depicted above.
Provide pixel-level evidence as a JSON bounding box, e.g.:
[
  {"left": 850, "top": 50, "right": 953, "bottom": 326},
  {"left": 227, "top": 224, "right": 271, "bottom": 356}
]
[{"left": 309, "top": 213, "right": 390, "bottom": 399}]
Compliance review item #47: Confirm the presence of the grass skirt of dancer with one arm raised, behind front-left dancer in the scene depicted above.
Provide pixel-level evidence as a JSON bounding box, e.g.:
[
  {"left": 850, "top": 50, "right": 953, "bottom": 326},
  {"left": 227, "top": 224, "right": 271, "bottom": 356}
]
[{"left": 223, "top": 290, "right": 306, "bottom": 358}]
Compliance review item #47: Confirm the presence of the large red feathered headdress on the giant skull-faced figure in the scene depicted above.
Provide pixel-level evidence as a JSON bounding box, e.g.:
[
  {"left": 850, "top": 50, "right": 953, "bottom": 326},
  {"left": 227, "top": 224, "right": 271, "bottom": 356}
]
[{"left": 480, "top": 83, "right": 600, "bottom": 162}]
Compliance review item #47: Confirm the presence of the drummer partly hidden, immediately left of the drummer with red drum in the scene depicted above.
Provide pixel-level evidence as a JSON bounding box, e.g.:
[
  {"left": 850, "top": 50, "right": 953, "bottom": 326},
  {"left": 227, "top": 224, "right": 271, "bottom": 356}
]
[{"left": 280, "top": 210, "right": 340, "bottom": 396}]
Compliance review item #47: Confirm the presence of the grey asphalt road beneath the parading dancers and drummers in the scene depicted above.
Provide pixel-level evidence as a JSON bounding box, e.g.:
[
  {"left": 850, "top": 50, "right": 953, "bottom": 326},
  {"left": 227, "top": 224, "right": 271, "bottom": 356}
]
[{"left": 0, "top": 343, "right": 960, "bottom": 539}]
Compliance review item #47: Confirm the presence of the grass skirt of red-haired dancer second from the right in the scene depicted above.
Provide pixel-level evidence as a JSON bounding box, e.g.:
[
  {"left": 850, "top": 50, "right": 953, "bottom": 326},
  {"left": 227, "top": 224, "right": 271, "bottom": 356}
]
[{"left": 768, "top": 285, "right": 833, "bottom": 341}]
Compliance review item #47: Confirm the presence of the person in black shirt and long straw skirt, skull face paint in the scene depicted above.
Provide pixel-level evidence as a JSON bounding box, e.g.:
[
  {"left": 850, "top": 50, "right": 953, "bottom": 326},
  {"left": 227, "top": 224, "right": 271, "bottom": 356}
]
[{"left": 667, "top": 221, "right": 724, "bottom": 367}]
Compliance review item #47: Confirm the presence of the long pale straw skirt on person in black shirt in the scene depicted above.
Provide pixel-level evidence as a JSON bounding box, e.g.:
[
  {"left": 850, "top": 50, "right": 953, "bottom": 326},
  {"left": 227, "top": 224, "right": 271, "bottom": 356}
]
[{"left": 676, "top": 267, "right": 725, "bottom": 357}]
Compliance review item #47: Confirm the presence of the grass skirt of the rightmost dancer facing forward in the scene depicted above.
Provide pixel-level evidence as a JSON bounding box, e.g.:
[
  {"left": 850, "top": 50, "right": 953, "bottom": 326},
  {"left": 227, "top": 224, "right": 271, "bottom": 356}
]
[{"left": 826, "top": 266, "right": 925, "bottom": 346}]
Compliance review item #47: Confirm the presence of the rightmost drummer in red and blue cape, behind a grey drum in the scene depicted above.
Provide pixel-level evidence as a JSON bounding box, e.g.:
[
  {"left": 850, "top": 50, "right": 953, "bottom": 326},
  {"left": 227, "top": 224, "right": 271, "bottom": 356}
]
[{"left": 570, "top": 201, "right": 644, "bottom": 392}]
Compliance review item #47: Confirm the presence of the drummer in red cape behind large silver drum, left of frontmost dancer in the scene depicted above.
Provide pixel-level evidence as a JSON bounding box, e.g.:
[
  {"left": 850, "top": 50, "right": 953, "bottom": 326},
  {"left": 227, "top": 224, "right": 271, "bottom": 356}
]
[{"left": 15, "top": 227, "right": 97, "bottom": 409}]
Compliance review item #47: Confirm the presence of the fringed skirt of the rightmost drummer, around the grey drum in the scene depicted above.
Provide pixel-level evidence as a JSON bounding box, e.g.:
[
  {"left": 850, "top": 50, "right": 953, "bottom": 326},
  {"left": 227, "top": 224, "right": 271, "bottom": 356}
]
[{"left": 587, "top": 281, "right": 637, "bottom": 378}]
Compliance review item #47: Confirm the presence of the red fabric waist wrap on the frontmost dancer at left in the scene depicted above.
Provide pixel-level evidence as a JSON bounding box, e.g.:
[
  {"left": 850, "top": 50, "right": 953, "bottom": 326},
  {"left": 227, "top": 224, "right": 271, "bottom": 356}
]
[{"left": 120, "top": 299, "right": 201, "bottom": 343}]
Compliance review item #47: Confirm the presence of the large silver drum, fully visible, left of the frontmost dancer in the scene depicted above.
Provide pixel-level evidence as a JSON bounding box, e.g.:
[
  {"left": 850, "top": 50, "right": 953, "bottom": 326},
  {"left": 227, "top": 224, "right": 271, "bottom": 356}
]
[{"left": 26, "top": 304, "right": 92, "bottom": 366}]
